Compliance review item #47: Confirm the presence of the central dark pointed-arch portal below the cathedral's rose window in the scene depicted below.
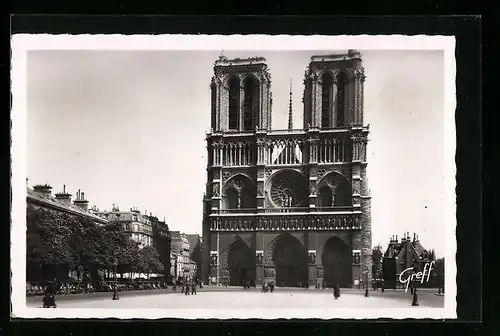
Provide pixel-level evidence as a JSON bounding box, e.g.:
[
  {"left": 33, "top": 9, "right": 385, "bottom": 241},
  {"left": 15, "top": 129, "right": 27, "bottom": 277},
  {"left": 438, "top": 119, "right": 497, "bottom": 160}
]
[{"left": 272, "top": 233, "right": 308, "bottom": 287}]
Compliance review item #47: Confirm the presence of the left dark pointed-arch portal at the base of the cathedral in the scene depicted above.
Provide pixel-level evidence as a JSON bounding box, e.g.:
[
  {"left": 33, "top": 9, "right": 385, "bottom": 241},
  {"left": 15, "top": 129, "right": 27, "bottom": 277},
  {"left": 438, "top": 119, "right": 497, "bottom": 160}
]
[{"left": 227, "top": 236, "right": 255, "bottom": 286}]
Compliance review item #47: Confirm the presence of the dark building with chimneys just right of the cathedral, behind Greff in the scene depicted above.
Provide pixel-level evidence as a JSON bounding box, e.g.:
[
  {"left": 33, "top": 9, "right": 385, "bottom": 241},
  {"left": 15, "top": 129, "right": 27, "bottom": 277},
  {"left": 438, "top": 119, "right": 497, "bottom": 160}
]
[{"left": 382, "top": 232, "right": 436, "bottom": 288}]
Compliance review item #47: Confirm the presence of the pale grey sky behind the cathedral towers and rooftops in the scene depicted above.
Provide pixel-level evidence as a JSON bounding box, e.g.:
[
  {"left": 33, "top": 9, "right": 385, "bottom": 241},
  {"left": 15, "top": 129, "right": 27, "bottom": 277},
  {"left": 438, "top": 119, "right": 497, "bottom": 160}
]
[{"left": 27, "top": 50, "right": 445, "bottom": 257}]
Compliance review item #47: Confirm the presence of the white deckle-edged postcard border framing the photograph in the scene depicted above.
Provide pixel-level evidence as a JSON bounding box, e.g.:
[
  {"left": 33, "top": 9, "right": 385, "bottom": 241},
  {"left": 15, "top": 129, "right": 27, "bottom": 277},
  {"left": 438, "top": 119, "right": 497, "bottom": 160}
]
[{"left": 11, "top": 34, "right": 457, "bottom": 319}]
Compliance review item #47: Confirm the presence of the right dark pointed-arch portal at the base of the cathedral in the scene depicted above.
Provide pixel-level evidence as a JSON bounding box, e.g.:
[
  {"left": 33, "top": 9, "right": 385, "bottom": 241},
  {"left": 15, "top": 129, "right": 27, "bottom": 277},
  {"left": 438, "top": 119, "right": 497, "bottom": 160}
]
[{"left": 321, "top": 237, "right": 352, "bottom": 287}]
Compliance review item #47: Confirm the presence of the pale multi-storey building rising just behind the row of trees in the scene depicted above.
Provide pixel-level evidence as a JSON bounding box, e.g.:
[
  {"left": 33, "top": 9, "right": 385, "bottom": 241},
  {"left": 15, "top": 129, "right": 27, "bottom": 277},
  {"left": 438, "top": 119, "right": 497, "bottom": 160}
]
[{"left": 95, "top": 205, "right": 153, "bottom": 248}]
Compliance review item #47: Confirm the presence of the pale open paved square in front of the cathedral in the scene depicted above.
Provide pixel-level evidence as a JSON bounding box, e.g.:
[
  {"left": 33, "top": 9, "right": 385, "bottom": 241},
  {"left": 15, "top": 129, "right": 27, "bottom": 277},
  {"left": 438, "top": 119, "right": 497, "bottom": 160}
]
[{"left": 27, "top": 288, "right": 444, "bottom": 309}]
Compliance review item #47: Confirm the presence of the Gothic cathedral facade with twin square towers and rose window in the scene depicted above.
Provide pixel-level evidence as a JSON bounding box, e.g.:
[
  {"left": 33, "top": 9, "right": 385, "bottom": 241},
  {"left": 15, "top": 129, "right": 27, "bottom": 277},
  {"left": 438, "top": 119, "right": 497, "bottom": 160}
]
[{"left": 202, "top": 50, "right": 372, "bottom": 287}]
